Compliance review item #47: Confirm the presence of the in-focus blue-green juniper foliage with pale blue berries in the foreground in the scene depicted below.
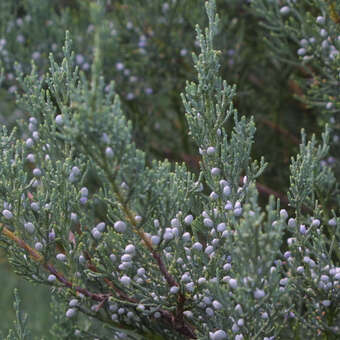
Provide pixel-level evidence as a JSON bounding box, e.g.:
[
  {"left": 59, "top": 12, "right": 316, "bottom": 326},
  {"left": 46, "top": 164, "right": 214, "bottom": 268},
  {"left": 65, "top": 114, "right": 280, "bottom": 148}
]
[{"left": 0, "top": 0, "right": 340, "bottom": 340}]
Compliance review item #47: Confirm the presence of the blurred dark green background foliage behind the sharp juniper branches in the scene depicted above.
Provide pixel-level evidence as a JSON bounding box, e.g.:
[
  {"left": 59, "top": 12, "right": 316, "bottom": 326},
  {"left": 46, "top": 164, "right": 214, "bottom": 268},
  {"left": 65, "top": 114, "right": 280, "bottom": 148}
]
[{"left": 0, "top": 0, "right": 340, "bottom": 336}]
